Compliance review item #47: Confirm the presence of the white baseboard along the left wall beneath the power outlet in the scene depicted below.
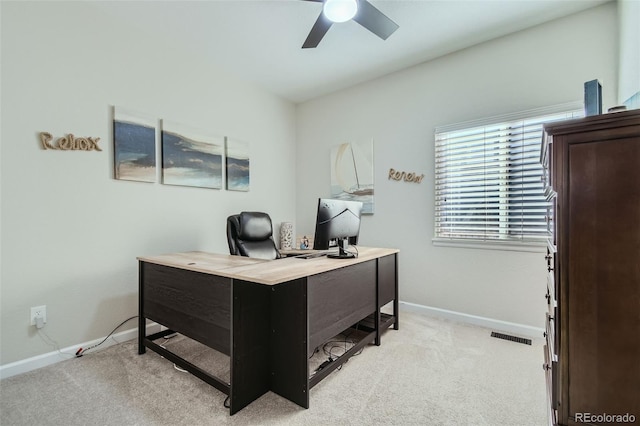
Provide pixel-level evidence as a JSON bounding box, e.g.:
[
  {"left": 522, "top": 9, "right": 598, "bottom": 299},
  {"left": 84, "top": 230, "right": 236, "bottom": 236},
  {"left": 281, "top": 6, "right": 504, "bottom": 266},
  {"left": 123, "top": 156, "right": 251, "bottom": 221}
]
[{"left": 0, "top": 323, "right": 160, "bottom": 380}]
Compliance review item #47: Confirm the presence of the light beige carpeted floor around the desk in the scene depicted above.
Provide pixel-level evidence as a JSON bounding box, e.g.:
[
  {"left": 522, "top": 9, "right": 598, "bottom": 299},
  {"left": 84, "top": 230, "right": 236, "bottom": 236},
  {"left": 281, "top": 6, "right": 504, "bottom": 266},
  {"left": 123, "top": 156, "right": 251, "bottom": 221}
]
[{"left": 0, "top": 311, "right": 546, "bottom": 426}]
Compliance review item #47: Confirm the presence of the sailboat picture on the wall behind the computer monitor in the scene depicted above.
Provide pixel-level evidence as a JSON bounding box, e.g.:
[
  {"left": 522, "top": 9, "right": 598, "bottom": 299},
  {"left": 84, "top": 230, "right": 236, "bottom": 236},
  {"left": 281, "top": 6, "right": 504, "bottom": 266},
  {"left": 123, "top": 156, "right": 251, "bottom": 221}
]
[{"left": 331, "top": 140, "right": 374, "bottom": 214}]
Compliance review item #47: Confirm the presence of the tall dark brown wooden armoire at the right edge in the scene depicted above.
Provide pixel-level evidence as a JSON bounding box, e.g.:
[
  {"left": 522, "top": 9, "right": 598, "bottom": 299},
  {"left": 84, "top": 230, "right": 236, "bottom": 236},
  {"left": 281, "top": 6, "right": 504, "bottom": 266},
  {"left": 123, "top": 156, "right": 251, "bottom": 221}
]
[{"left": 541, "top": 110, "right": 640, "bottom": 425}]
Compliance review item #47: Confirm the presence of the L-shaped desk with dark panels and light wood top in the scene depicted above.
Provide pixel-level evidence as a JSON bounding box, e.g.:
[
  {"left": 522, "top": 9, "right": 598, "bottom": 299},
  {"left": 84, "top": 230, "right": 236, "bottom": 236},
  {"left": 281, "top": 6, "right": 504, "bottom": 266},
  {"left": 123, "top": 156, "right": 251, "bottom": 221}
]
[{"left": 138, "top": 247, "right": 398, "bottom": 414}]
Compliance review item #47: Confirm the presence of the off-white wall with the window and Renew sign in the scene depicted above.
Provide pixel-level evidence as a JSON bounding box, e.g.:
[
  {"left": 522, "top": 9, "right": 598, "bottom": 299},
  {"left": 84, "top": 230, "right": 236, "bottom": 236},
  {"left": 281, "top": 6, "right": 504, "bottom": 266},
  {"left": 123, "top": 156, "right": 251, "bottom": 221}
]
[{"left": 297, "top": 3, "right": 618, "bottom": 327}]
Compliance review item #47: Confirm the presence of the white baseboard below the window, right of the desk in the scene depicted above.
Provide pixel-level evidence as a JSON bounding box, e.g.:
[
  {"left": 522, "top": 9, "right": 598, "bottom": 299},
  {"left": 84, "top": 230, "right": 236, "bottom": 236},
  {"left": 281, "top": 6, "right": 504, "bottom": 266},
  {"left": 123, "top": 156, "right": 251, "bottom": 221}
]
[{"left": 399, "top": 301, "right": 544, "bottom": 339}]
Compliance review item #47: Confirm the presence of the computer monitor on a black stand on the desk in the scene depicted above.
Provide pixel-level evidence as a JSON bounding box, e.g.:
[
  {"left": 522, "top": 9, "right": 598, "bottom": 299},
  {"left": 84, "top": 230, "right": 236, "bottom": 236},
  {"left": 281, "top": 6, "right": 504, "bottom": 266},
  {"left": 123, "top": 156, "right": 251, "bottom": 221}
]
[{"left": 313, "top": 198, "right": 362, "bottom": 259}]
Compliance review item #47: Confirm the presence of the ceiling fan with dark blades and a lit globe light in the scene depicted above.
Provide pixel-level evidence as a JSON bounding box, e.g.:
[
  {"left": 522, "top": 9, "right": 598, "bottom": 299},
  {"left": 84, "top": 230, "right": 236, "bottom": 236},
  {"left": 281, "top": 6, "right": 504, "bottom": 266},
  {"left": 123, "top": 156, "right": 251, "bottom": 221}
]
[{"left": 302, "top": 0, "right": 398, "bottom": 49}]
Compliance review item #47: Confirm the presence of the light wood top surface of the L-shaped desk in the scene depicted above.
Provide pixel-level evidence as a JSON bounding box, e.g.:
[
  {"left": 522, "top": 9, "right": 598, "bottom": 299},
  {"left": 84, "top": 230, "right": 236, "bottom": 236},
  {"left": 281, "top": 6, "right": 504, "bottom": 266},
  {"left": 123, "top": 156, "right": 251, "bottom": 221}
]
[{"left": 138, "top": 247, "right": 399, "bottom": 285}]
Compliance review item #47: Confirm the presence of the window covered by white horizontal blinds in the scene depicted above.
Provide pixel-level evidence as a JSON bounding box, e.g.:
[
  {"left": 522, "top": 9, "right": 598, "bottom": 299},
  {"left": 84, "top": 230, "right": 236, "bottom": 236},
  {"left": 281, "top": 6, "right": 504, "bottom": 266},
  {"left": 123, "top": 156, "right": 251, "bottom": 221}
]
[{"left": 434, "top": 104, "right": 584, "bottom": 250}]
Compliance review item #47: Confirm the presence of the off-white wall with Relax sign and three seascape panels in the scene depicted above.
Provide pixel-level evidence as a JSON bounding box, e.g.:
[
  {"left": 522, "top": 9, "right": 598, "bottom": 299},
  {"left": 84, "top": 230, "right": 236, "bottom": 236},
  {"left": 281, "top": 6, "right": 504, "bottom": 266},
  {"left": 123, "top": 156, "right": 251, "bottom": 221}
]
[{"left": 0, "top": 2, "right": 295, "bottom": 365}]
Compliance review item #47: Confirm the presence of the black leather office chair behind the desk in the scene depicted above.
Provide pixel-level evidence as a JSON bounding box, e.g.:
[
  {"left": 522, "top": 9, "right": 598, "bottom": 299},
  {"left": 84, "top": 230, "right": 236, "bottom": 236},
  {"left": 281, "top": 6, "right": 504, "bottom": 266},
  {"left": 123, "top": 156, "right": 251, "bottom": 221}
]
[{"left": 227, "top": 212, "right": 280, "bottom": 260}]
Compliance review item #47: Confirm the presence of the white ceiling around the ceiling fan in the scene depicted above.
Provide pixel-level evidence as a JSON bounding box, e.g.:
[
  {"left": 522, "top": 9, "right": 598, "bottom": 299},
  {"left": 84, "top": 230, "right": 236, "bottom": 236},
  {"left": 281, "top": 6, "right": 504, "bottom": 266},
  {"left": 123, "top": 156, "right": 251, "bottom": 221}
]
[{"left": 93, "top": 0, "right": 608, "bottom": 102}]
